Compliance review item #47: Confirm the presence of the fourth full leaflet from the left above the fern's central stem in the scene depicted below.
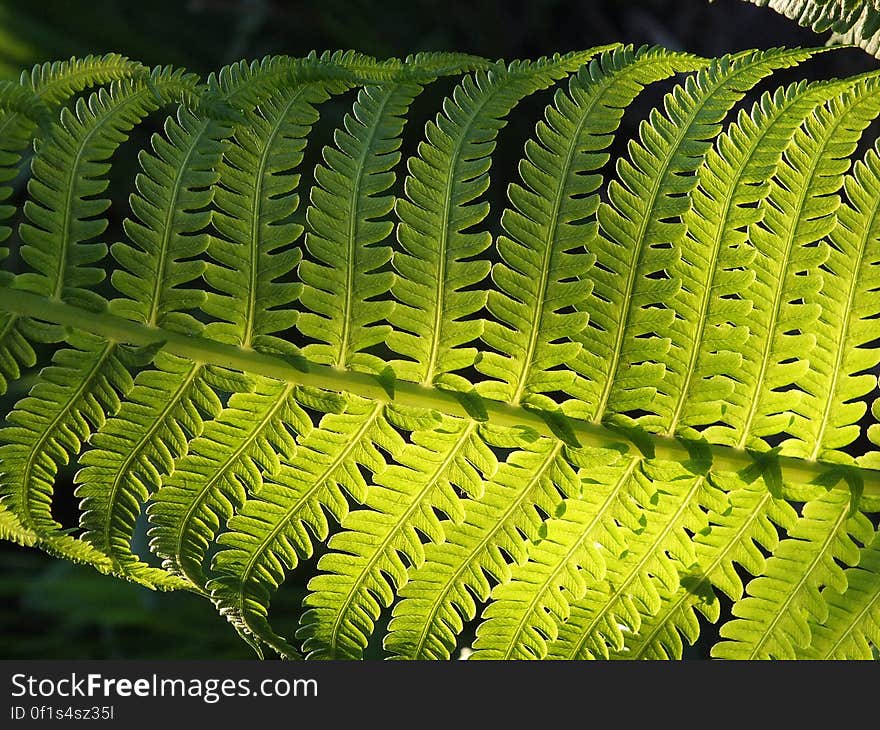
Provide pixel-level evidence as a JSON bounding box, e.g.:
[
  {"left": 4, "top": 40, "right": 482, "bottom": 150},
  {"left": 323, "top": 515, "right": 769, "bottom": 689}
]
[{"left": 297, "top": 83, "right": 422, "bottom": 372}]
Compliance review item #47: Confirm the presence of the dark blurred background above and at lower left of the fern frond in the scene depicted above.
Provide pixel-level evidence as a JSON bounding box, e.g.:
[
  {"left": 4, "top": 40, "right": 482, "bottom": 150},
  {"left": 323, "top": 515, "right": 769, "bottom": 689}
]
[{"left": 0, "top": 0, "right": 877, "bottom": 659}]
